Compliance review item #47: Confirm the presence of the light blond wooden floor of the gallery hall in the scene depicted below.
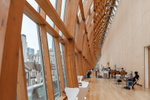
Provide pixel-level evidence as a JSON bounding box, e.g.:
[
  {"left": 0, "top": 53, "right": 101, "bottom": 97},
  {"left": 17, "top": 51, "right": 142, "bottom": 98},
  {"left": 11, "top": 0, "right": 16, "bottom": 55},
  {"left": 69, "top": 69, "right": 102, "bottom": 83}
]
[{"left": 86, "top": 73, "right": 150, "bottom": 100}]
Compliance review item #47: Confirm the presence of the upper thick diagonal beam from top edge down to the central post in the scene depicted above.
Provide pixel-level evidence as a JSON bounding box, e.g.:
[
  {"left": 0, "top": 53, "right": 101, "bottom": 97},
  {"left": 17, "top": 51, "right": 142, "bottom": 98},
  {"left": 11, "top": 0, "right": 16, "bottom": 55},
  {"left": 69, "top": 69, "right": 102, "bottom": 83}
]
[{"left": 35, "top": 0, "right": 72, "bottom": 38}]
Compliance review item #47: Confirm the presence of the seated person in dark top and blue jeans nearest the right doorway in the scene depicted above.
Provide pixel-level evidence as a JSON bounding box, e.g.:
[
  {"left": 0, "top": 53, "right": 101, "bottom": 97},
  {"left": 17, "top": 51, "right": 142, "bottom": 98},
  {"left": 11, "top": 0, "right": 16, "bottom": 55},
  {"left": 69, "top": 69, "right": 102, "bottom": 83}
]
[{"left": 124, "top": 71, "right": 139, "bottom": 89}]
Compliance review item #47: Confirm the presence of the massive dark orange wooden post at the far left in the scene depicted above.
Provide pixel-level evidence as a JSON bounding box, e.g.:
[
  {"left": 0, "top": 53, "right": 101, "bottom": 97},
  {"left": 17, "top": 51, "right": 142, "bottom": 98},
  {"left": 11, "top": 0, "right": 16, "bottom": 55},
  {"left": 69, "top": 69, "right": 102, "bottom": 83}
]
[{"left": 0, "top": 0, "right": 25, "bottom": 100}]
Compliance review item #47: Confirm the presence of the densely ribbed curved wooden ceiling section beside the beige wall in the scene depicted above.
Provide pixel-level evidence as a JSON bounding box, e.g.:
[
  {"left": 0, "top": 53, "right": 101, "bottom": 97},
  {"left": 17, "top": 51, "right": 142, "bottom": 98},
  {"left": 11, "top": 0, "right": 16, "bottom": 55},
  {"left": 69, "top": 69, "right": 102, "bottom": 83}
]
[{"left": 93, "top": 0, "right": 119, "bottom": 59}]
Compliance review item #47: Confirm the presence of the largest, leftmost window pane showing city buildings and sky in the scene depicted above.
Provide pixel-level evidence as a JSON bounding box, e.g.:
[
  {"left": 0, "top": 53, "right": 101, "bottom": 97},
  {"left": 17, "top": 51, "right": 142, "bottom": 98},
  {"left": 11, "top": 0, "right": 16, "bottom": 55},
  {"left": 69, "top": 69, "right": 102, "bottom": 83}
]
[{"left": 21, "top": 14, "right": 47, "bottom": 100}]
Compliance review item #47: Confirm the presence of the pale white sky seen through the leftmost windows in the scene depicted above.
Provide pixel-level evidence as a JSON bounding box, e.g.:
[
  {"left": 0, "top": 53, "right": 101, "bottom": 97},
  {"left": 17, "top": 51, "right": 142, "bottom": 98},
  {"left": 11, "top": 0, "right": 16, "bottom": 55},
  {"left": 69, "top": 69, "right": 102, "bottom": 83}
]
[{"left": 21, "top": 0, "right": 57, "bottom": 54}]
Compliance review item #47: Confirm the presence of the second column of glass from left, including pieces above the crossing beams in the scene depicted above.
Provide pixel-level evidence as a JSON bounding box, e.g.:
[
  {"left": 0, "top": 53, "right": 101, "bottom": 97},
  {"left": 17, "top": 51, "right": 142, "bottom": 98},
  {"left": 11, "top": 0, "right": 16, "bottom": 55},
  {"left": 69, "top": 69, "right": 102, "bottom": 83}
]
[{"left": 46, "top": 0, "right": 61, "bottom": 100}]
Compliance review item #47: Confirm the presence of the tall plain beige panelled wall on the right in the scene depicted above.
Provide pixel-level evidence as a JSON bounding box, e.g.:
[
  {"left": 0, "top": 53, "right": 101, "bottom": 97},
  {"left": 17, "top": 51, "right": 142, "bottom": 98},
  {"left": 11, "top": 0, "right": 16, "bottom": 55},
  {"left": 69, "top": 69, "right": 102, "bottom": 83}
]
[{"left": 100, "top": 0, "right": 150, "bottom": 85}]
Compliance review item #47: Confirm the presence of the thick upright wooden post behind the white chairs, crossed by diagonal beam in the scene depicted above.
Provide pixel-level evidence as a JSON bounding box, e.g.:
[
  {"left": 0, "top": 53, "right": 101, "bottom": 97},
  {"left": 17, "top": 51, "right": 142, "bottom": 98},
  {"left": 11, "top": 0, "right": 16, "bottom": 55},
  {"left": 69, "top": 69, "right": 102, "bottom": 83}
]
[{"left": 65, "top": 0, "right": 79, "bottom": 87}]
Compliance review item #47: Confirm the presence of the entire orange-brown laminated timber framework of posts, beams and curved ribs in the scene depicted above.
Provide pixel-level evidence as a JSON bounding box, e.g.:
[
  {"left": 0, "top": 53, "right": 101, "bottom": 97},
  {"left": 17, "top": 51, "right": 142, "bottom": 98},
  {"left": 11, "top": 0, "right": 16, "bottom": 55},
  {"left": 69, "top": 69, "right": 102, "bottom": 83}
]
[{"left": 0, "top": 0, "right": 119, "bottom": 100}]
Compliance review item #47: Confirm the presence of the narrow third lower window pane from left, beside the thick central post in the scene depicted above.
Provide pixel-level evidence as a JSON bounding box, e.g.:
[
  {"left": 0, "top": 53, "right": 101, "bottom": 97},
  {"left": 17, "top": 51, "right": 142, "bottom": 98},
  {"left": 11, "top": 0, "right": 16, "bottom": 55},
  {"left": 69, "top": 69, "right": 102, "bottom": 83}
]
[{"left": 60, "top": 43, "right": 68, "bottom": 87}]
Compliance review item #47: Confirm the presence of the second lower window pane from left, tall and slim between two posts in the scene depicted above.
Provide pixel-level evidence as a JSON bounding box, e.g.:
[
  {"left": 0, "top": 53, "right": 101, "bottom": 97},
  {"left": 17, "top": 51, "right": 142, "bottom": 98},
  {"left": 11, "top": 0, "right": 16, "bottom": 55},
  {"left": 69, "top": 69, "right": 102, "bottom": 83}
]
[{"left": 47, "top": 33, "right": 61, "bottom": 99}]
